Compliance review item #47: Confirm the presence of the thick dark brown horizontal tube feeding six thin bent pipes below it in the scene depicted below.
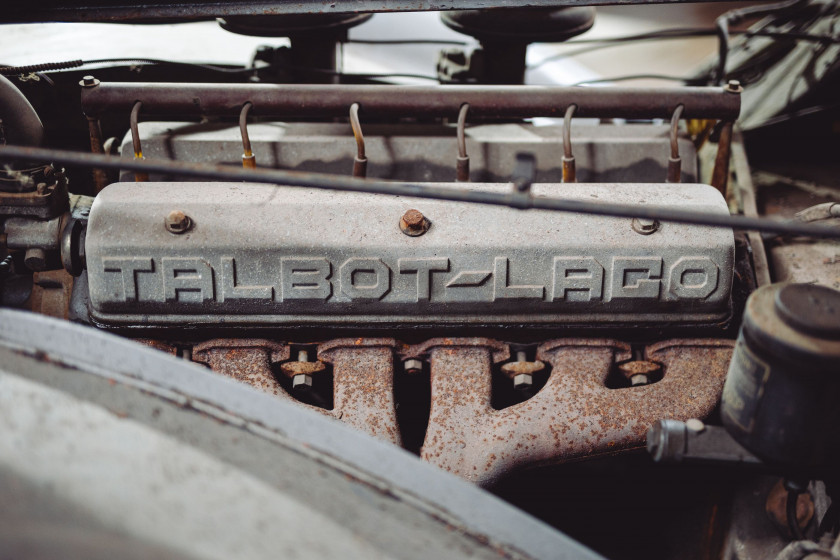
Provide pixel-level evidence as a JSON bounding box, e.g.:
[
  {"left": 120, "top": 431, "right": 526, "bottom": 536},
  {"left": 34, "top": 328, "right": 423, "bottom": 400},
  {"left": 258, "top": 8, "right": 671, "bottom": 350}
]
[{"left": 82, "top": 83, "right": 741, "bottom": 121}]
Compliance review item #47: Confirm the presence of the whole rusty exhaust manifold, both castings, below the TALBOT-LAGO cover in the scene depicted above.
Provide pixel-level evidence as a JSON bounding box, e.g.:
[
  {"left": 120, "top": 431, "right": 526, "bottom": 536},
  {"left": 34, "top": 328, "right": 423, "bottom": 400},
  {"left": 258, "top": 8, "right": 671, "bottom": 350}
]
[{"left": 180, "top": 338, "right": 733, "bottom": 486}]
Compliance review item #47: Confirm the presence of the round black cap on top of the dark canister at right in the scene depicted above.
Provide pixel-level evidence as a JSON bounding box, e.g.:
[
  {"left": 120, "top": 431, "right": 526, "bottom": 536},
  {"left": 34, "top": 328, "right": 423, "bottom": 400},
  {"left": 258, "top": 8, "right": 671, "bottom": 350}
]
[{"left": 775, "top": 284, "right": 840, "bottom": 339}]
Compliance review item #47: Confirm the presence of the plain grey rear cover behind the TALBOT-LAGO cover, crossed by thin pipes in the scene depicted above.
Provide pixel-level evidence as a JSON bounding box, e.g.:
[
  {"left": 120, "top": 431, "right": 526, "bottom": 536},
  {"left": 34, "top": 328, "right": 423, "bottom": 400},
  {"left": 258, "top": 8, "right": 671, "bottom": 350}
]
[{"left": 120, "top": 121, "right": 698, "bottom": 183}]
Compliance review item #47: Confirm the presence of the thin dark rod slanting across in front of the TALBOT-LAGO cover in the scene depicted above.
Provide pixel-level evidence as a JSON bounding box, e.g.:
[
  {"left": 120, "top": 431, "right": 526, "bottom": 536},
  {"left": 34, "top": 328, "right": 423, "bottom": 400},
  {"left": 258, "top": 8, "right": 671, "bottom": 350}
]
[{"left": 0, "top": 146, "right": 840, "bottom": 239}]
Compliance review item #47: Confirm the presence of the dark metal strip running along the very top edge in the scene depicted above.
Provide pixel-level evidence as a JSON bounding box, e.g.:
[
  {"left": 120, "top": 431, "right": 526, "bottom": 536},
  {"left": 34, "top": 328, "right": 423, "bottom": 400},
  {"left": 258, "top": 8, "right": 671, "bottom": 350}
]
[{"left": 0, "top": 0, "right": 740, "bottom": 23}]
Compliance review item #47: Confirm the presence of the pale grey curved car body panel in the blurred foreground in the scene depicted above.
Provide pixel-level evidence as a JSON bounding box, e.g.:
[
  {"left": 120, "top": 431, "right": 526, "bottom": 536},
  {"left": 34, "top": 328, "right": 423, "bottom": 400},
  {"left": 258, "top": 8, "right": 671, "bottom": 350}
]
[{"left": 0, "top": 309, "right": 599, "bottom": 560}]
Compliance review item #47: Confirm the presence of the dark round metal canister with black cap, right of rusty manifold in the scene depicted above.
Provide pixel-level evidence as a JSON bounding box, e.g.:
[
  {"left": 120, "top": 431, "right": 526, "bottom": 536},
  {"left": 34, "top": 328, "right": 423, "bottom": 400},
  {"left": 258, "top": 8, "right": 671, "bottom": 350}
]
[{"left": 721, "top": 284, "right": 840, "bottom": 470}]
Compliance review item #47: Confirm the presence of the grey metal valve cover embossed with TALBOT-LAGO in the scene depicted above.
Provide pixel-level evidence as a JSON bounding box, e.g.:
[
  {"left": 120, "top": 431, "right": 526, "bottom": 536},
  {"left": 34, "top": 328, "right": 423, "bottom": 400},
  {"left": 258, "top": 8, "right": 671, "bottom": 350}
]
[{"left": 86, "top": 182, "right": 734, "bottom": 326}]
